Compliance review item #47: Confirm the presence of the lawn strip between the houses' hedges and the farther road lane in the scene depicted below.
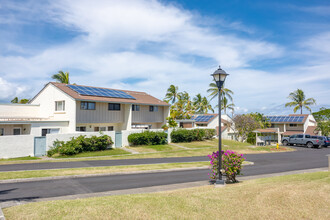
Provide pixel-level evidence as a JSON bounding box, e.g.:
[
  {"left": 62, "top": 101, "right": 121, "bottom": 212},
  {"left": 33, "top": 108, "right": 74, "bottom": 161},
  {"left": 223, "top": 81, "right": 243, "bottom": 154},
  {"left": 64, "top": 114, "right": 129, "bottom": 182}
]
[{"left": 0, "top": 139, "right": 293, "bottom": 164}]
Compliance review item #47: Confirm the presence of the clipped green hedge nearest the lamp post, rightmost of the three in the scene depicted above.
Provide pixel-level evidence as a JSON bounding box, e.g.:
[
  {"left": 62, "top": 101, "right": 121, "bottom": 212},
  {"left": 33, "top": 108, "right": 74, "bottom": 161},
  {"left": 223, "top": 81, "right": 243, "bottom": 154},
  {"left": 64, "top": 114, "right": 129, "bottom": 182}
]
[{"left": 171, "top": 128, "right": 215, "bottom": 143}]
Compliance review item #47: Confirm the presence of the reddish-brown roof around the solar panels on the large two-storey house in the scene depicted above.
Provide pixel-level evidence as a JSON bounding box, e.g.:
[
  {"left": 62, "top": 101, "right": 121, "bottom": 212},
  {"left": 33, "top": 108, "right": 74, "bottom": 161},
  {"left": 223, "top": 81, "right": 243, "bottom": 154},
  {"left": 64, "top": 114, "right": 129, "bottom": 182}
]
[{"left": 50, "top": 82, "right": 170, "bottom": 106}]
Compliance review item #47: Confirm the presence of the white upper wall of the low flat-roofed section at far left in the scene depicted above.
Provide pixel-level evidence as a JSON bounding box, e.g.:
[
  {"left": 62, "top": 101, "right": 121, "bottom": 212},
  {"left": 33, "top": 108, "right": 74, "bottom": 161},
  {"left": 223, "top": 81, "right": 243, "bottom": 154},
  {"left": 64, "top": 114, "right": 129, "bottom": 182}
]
[{"left": 0, "top": 104, "right": 40, "bottom": 118}]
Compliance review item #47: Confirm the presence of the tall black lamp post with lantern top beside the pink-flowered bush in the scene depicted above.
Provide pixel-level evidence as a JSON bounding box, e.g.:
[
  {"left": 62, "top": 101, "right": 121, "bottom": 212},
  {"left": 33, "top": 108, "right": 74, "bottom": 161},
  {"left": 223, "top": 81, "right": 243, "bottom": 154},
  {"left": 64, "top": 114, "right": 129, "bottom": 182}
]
[{"left": 211, "top": 66, "right": 229, "bottom": 185}]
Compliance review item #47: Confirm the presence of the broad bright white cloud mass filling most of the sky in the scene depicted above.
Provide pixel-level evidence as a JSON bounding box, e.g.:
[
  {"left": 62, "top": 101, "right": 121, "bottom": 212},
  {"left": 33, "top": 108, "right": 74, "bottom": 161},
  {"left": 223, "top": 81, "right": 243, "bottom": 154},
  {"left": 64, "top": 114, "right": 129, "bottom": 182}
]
[{"left": 0, "top": 0, "right": 330, "bottom": 112}]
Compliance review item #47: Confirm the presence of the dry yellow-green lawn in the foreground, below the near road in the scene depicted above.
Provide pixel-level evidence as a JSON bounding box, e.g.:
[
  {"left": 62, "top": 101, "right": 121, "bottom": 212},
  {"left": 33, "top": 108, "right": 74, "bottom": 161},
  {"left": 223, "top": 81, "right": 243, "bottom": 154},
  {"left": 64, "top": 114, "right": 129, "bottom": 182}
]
[{"left": 3, "top": 172, "right": 330, "bottom": 220}]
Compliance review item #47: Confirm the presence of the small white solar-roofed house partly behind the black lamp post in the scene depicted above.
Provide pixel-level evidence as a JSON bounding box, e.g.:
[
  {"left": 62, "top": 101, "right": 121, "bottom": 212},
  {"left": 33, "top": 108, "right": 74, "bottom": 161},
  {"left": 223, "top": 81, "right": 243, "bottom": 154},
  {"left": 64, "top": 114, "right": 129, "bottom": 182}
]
[{"left": 176, "top": 114, "right": 236, "bottom": 140}]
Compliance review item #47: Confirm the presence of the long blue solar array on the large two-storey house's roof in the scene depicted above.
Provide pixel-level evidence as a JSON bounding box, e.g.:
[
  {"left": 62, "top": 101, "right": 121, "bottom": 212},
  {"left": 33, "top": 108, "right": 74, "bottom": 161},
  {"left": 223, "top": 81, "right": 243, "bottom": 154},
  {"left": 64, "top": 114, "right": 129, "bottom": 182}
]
[{"left": 68, "top": 85, "right": 135, "bottom": 99}]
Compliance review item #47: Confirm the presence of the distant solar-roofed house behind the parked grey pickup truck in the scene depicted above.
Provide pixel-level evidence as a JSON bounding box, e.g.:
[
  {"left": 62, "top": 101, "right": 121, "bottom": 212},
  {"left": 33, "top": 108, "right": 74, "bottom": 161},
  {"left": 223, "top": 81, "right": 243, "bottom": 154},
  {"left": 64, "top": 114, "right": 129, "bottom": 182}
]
[{"left": 254, "top": 114, "right": 319, "bottom": 143}]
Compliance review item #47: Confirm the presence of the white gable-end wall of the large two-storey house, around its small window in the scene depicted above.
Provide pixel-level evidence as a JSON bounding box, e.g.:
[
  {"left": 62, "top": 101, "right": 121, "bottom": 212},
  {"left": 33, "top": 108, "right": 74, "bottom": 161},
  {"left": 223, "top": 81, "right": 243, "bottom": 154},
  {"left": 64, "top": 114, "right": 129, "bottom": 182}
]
[{"left": 31, "top": 84, "right": 76, "bottom": 132}]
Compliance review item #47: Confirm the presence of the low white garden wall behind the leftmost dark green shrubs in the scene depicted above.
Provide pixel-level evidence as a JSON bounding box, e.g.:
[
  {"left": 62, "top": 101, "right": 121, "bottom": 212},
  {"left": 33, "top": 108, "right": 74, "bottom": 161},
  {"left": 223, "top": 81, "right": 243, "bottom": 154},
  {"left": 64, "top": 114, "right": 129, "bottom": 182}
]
[{"left": 46, "top": 131, "right": 115, "bottom": 151}]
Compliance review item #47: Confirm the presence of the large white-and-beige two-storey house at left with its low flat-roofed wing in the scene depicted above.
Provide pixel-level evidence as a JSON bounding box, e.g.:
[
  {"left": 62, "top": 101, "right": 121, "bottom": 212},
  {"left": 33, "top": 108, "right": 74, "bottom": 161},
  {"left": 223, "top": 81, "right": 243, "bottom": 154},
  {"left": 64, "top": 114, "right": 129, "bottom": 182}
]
[{"left": 0, "top": 82, "right": 170, "bottom": 136}]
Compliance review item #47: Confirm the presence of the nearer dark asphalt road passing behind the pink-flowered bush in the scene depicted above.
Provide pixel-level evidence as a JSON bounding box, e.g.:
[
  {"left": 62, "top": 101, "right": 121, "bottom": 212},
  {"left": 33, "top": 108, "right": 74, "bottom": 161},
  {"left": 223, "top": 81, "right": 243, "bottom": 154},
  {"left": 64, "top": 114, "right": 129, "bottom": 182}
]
[{"left": 0, "top": 148, "right": 330, "bottom": 202}]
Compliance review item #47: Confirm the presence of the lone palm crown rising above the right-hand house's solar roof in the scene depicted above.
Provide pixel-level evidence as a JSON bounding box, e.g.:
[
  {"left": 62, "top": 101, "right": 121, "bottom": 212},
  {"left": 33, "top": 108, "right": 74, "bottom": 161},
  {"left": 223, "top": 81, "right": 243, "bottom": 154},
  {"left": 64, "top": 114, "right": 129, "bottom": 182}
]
[{"left": 285, "top": 89, "right": 316, "bottom": 114}]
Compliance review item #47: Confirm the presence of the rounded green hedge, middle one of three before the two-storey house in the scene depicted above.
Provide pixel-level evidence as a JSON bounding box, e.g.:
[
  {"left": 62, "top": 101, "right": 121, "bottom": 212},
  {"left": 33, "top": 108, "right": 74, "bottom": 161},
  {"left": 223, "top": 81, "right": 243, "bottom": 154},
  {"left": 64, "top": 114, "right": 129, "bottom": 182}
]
[{"left": 127, "top": 131, "right": 167, "bottom": 146}]
